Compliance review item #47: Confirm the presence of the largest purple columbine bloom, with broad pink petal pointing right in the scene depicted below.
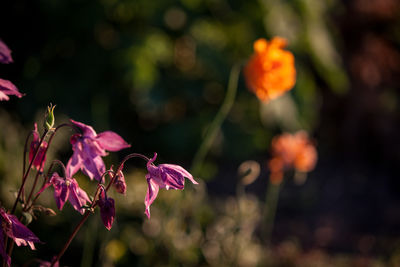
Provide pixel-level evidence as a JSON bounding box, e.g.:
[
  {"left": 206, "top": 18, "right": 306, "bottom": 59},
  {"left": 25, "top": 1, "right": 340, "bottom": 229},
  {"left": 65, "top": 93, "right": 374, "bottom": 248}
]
[{"left": 68, "top": 120, "right": 130, "bottom": 181}]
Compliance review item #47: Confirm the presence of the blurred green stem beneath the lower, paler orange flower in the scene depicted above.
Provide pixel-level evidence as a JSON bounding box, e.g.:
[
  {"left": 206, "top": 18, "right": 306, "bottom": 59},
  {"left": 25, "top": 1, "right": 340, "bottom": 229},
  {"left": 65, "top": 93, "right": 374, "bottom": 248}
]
[{"left": 262, "top": 182, "right": 281, "bottom": 246}]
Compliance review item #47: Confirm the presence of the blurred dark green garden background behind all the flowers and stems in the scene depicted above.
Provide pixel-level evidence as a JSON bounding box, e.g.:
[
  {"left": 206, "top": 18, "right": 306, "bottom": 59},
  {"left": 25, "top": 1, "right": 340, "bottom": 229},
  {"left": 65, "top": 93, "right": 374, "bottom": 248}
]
[{"left": 0, "top": 0, "right": 400, "bottom": 266}]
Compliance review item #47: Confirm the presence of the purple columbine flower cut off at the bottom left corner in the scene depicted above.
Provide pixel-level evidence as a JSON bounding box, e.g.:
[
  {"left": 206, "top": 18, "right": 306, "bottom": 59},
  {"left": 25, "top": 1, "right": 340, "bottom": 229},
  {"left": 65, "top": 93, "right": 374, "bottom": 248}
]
[{"left": 0, "top": 208, "right": 40, "bottom": 266}]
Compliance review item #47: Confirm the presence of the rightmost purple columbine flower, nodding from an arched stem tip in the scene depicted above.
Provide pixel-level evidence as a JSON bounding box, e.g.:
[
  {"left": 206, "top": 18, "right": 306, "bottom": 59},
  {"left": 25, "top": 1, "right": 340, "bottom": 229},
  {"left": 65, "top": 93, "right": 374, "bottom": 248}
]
[{"left": 144, "top": 153, "right": 198, "bottom": 219}]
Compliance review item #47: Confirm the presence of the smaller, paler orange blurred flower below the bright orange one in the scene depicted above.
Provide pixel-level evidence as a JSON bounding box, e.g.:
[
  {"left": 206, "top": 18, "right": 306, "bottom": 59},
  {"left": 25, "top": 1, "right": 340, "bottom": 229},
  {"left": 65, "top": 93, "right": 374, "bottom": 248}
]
[{"left": 268, "top": 131, "right": 317, "bottom": 184}]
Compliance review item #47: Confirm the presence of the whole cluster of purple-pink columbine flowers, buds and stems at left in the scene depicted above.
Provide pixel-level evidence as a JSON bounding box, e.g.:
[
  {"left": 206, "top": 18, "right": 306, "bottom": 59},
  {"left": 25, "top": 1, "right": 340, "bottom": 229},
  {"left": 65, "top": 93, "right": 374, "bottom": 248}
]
[{"left": 0, "top": 41, "right": 197, "bottom": 266}]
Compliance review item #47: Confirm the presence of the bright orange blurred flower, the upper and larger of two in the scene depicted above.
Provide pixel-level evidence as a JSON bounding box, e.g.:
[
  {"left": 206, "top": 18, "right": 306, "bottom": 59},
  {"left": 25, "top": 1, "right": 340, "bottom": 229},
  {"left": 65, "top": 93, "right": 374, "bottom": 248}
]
[{"left": 244, "top": 37, "right": 296, "bottom": 101}]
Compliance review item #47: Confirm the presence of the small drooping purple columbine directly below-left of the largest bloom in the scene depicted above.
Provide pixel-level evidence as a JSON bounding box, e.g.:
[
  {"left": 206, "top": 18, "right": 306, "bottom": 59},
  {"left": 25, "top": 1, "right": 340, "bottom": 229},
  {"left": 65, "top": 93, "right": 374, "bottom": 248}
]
[{"left": 46, "top": 174, "right": 90, "bottom": 214}]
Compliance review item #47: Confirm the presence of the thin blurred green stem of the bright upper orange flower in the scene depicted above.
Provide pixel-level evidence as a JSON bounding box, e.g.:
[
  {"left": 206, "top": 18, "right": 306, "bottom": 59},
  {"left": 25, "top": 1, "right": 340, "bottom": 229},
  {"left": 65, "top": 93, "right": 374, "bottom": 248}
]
[{"left": 191, "top": 64, "right": 240, "bottom": 175}]
